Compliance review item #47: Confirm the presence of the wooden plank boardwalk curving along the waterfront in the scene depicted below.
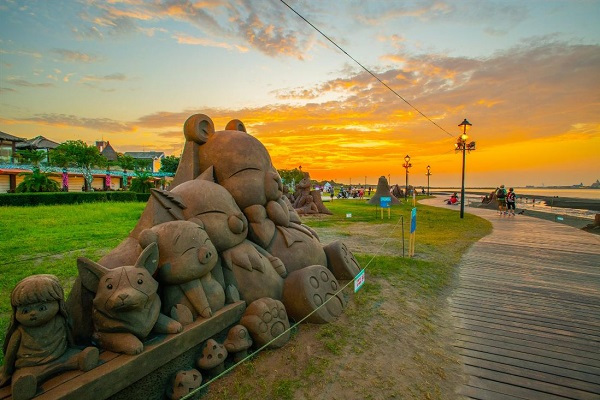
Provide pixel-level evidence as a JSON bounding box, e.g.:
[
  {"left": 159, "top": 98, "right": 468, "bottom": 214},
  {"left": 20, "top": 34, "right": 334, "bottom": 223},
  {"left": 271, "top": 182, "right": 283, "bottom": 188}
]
[{"left": 421, "top": 197, "right": 600, "bottom": 400}]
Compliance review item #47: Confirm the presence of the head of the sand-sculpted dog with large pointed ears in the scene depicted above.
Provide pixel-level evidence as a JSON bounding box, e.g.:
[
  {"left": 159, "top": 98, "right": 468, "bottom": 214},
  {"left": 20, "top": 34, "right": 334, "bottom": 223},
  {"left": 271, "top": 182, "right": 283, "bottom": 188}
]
[{"left": 77, "top": 243, "right": 161, "bottom": 338}]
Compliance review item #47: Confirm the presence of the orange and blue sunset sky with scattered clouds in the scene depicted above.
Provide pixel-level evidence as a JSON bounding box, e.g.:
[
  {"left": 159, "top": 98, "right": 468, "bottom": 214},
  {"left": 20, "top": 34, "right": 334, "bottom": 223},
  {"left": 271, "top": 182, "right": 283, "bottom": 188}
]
[{"left": 0, "top": 0, "right": 600, "bottom": 187}]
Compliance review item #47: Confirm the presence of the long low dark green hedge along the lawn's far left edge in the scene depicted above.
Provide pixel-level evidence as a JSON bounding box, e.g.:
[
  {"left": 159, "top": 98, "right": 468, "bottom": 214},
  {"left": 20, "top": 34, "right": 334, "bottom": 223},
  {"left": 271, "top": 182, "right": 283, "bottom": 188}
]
[{"left": 0, "top": 191, "right": 150, "bottom": 206}]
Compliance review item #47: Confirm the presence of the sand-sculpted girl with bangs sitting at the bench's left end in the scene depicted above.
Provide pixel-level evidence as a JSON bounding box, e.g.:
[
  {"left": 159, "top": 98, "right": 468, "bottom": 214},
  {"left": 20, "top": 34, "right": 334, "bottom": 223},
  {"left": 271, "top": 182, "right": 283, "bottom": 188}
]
[{"left": 0, "top": 275, "right": 98, "bottom": 400}]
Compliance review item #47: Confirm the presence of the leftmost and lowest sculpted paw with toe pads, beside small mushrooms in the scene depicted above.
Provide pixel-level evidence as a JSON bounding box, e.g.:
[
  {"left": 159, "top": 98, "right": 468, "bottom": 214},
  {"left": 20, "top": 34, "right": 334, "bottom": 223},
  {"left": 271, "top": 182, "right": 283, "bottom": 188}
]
[{"left": 240, "top": 297, "right": 290, "bottom": 349}]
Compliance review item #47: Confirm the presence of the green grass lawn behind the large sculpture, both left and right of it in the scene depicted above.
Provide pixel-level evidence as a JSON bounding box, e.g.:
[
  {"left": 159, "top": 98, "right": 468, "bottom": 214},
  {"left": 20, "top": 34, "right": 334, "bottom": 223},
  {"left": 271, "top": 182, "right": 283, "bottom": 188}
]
[{"left": 0, "top": 200, "right": 491, "bottom": 372}]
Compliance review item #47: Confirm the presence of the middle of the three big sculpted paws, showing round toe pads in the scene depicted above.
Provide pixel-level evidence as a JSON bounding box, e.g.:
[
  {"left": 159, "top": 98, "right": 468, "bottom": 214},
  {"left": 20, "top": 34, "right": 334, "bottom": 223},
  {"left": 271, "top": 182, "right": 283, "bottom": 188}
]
[{"left": 282, "top": 265, "right": 346, "bottom": 324}]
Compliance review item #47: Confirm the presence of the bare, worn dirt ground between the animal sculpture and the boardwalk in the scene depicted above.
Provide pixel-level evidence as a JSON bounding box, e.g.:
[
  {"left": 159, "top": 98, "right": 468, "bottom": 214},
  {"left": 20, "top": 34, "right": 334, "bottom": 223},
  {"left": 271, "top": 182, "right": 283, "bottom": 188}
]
[{"left": 202, "top": 224, "right": 463, "bottom": 400}]
